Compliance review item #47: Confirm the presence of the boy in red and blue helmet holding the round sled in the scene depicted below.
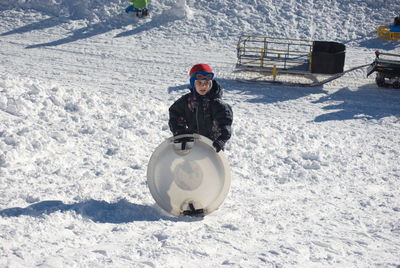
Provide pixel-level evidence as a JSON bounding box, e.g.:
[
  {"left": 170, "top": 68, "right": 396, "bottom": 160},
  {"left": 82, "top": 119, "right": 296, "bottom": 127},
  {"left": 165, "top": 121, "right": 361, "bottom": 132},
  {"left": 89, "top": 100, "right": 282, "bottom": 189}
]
[{"left": 169, "top": 63, "right": 233, "bottom": 152}]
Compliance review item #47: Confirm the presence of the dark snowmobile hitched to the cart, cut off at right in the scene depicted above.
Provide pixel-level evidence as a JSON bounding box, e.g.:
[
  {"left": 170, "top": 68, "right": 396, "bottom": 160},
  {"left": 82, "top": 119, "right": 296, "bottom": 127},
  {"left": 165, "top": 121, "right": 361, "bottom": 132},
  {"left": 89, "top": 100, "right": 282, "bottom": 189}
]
[{"left": 367, "top": 51, "right": 400, "bottom": 88}]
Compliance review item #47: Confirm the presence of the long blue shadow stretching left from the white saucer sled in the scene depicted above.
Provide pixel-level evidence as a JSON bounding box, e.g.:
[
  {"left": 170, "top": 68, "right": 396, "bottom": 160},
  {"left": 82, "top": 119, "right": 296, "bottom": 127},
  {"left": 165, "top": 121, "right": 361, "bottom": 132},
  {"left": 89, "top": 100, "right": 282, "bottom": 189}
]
[{"left": 0, "top": 199, "right": 194, "bottom": 223}]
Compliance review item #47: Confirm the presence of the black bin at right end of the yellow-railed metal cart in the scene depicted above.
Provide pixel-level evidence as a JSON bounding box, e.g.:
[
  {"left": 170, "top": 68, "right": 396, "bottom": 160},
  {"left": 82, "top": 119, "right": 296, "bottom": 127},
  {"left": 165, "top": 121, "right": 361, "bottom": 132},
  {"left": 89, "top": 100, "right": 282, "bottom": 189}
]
[{"left": 311, "top": 41, "right": 346, "bottom": 74}]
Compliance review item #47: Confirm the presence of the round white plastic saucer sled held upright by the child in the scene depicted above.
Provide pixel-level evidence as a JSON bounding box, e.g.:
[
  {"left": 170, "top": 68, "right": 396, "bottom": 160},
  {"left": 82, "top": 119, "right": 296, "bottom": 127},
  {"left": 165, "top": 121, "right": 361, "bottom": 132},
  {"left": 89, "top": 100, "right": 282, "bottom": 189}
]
[{"left": 147, "top": 134, "right": 231, "bottom": 216}]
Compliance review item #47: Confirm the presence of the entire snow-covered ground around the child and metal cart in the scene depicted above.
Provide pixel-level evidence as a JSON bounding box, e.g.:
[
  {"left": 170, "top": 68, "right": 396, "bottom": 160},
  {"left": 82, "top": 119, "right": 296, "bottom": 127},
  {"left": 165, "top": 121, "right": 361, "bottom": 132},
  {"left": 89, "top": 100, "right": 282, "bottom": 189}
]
[{"left": 0, "top": 0, "right": 400, "bottom": 267}]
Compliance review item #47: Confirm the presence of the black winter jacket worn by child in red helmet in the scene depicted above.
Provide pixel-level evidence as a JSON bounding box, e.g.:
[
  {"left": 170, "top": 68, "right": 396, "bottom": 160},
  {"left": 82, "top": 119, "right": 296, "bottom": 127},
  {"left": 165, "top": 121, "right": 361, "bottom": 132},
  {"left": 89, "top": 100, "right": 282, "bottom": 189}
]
[{"left": 169, "top": 80, "right": 233, "bottom": 147}]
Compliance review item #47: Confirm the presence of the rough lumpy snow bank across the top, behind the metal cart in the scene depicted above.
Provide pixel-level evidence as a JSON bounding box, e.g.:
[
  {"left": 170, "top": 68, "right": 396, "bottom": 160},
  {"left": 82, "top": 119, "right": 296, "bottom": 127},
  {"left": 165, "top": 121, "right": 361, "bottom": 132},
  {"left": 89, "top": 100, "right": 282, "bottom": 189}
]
[{"left": 0, "top": 0, "right": 398, "bottom": 43}]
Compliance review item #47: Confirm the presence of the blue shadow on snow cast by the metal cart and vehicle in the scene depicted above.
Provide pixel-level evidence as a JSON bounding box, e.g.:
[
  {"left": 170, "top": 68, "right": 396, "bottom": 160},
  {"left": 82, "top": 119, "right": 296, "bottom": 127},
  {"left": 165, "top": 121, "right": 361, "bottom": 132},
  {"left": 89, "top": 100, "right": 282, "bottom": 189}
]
[{"left": 168, "top": 79, "right": 400, "bottom": 122}]
